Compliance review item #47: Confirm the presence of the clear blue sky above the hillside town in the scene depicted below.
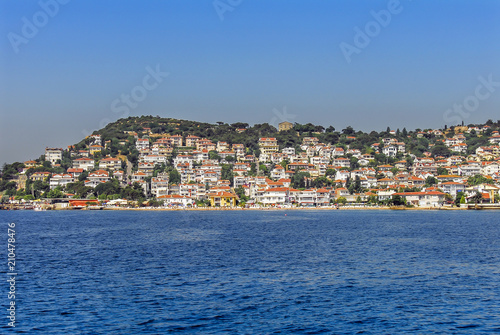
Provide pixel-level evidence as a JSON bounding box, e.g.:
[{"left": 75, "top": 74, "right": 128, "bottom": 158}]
[{"left": 0, "top": 0, "right": 500, "bottom": 164}]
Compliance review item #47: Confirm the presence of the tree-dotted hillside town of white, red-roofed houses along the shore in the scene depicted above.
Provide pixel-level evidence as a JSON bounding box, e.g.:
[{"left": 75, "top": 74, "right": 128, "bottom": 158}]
[{"left": 0, "top": 116, "right": 500, "bottom": 208}]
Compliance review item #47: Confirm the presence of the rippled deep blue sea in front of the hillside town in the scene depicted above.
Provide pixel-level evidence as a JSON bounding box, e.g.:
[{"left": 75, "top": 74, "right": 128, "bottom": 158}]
[{"left": 0, "top": 210, "right": 500, "bottom": 334}]
